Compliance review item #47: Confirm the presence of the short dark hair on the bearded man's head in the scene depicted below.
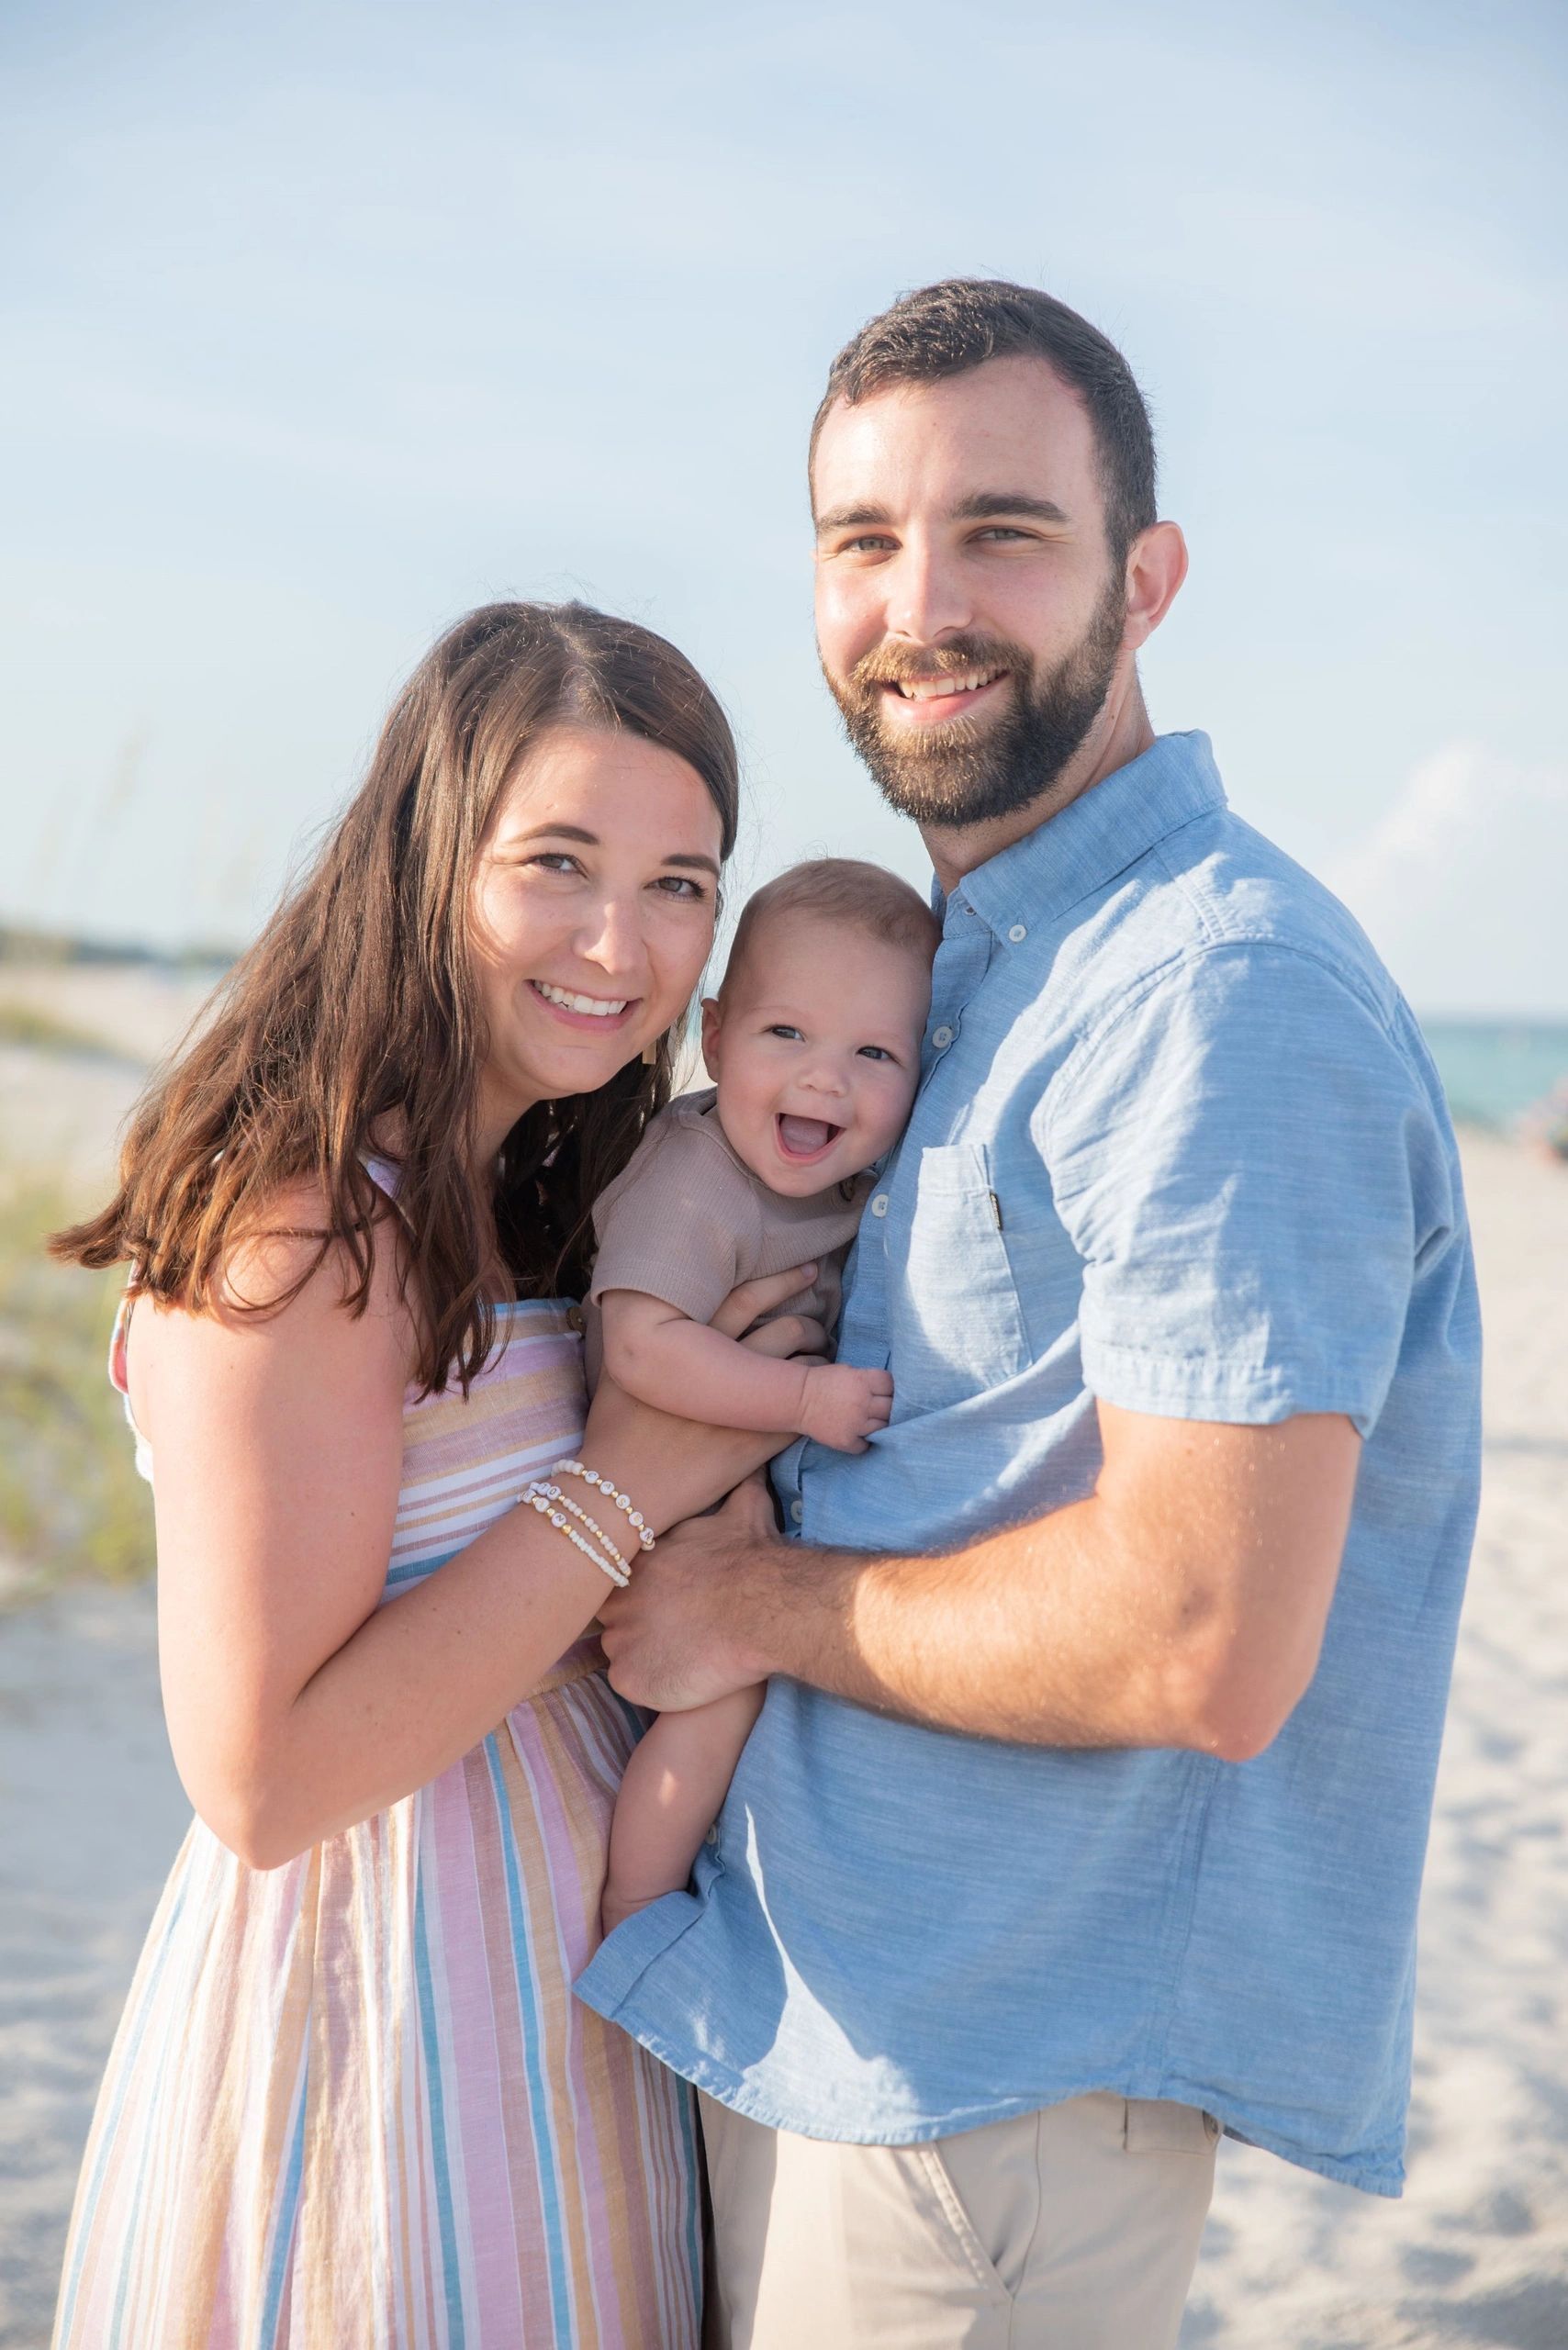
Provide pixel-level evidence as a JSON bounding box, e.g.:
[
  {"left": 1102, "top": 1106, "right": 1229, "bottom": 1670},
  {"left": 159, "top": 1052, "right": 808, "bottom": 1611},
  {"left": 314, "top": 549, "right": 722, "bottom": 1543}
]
[{"left": 811, "top": 277, "right": 1157, "bottom": 562}]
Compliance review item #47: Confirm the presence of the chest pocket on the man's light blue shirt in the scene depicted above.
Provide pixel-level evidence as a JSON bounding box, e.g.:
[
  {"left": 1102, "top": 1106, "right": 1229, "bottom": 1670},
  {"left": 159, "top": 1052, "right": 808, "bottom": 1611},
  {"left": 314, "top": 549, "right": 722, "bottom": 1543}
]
[{"left": 886, "top": 1142, "right": 1030, "bottom": 1419}]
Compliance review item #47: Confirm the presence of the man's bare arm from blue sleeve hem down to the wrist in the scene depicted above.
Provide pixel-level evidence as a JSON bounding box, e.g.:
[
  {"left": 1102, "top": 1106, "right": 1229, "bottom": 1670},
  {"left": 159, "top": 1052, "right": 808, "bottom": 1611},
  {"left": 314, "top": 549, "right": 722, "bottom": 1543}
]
[{"left": 736, "top": 1405, "right": 1361, "bottom": 1760}]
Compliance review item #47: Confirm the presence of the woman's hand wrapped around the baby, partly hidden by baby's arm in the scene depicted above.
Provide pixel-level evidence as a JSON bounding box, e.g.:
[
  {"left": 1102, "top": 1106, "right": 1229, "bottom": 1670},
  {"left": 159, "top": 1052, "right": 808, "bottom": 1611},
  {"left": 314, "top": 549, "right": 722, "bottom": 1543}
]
[{"left": 580, "top": 1264, "right": 825, "bottom": 1532}]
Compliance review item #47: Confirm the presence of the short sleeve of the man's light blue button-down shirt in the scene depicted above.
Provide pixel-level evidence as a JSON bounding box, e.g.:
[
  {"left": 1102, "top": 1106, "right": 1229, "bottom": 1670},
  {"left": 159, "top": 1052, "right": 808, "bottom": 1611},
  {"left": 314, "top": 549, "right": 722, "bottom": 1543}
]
[{"left": 1044, "top": 943, "right": 1437, "bottom": 1436}]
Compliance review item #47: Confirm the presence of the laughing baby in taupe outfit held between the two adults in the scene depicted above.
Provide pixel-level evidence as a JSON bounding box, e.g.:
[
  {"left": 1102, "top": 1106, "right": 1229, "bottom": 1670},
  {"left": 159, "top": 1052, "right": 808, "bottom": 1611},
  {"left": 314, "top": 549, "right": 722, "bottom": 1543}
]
[{"left": 590, "top": 857, "right": 938, "bottom": 1931}]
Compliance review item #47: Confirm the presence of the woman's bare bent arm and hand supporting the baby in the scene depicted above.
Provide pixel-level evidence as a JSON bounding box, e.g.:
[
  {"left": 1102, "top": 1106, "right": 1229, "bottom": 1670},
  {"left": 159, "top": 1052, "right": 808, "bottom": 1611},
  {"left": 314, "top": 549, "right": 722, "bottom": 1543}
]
[{"left": 131, "top": 1243, "right": 801, "bottom": 1868}]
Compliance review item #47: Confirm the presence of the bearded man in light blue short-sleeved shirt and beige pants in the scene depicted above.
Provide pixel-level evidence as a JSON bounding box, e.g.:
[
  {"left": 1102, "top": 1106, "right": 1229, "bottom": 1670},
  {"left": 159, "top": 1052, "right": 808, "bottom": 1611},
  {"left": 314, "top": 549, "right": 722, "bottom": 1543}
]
[{"left": 576, "top": 282, "right": 1479, "bottom": 2350}]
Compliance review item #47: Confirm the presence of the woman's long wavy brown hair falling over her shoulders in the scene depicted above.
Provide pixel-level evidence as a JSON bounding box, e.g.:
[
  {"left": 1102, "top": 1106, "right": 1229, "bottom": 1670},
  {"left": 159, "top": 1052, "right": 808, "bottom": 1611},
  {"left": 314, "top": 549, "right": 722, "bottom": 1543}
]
[{"left": 50, "top": 604, "right": 738, "bottom": 1389}]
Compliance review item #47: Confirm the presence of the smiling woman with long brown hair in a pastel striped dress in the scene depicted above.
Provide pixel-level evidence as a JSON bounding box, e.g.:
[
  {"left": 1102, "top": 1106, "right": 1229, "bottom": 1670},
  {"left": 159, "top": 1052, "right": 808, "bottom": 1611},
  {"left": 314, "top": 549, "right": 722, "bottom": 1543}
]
[{"left": 56, "top": 604, "right": 800, "bottom": 2350}]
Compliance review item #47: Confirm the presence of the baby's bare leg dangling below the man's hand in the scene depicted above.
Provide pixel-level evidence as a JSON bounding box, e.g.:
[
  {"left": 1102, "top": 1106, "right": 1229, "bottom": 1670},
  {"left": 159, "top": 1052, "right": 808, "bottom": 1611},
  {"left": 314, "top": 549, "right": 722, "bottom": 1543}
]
[{"left": 602, "top": 1683, "right": 764, "bottom": 1934}]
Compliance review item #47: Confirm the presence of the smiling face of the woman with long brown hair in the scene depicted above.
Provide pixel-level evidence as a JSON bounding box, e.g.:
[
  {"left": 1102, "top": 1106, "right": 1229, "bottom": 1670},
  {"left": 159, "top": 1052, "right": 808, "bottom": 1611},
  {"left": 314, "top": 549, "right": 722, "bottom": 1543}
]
[{"left": 473, "top": 726, "right": 720, "bottom": 1158}]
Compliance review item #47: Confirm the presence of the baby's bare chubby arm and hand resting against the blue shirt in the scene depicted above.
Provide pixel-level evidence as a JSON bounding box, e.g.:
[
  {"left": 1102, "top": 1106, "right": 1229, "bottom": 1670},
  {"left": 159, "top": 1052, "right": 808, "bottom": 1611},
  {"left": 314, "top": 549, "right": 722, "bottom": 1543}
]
[{"left": 599, "top": 1290, "right": 893, "bottom": 1452}]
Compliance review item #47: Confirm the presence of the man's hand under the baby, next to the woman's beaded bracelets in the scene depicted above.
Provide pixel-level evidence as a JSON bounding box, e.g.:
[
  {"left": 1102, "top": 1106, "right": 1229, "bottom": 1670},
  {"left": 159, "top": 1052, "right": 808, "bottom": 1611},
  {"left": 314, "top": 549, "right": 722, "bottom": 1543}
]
[{"left": 599, "top": 1476, "right": 783, "bottom": 1713}]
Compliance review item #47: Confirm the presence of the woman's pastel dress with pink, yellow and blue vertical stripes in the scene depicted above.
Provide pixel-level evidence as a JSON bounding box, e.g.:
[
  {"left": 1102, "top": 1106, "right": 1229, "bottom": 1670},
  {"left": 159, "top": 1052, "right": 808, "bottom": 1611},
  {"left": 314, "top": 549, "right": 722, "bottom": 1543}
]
[{"left": 54, "top": 1302, "right": 700, "bottom": 2350}]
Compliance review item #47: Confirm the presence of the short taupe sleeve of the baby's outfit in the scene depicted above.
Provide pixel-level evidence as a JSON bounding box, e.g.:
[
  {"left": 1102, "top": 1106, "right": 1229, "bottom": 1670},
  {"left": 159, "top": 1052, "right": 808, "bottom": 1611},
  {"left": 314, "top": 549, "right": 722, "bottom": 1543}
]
[{"left": 590, "top": 1125, "right": 757, "bottom": 1323}]
